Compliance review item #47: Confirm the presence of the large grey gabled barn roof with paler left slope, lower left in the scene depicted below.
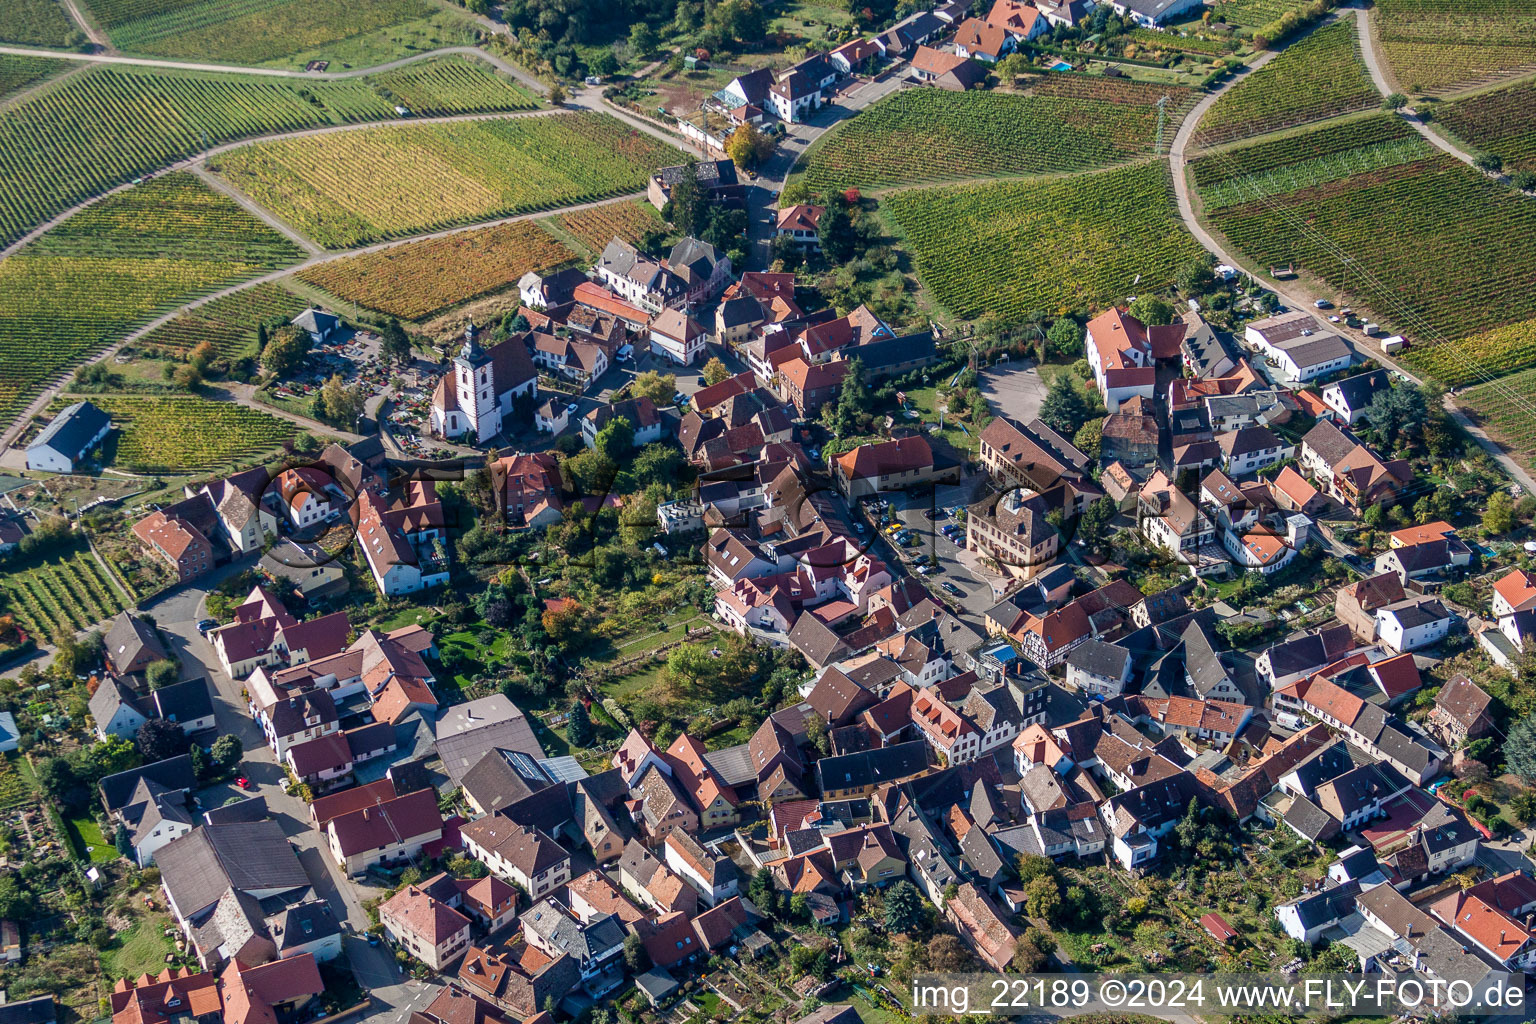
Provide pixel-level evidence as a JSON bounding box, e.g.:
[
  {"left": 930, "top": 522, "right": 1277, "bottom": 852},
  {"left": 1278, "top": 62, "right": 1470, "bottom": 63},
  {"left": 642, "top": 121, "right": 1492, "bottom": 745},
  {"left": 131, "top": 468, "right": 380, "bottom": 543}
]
[{"left": 155, "top": 821, "right": 309, "bottom": 915}]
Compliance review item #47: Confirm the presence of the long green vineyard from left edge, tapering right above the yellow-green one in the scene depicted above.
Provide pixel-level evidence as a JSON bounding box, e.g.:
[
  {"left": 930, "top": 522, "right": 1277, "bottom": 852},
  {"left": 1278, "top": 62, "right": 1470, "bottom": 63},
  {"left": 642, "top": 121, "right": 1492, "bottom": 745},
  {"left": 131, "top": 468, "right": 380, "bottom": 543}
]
[{"left": 0, "top": 60, "right": 530, "bottom": 251}]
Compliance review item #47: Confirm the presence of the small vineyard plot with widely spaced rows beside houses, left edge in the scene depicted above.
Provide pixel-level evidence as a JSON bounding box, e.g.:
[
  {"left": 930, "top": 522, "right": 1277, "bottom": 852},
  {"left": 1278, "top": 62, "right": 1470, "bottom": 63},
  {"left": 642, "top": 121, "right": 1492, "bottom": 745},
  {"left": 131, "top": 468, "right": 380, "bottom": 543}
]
[{"left": 0, "top": 543, "right": 123, "bottom": 642}]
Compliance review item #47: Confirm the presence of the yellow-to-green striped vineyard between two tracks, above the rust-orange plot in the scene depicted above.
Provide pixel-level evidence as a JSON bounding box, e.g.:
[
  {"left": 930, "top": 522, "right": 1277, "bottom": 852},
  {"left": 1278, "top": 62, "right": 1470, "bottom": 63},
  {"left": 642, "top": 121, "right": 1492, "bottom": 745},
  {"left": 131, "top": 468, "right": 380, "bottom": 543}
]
[{"left": 215, "top": 112, "right": 684, "bottom": 249}]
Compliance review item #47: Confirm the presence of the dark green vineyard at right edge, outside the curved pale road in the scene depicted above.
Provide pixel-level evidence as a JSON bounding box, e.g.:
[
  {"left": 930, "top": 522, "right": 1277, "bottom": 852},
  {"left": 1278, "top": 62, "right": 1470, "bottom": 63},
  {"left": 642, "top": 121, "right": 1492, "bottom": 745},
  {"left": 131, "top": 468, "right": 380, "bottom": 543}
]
[{"left": 1210, "top": 154, "right": 1536, "bottom": 346}]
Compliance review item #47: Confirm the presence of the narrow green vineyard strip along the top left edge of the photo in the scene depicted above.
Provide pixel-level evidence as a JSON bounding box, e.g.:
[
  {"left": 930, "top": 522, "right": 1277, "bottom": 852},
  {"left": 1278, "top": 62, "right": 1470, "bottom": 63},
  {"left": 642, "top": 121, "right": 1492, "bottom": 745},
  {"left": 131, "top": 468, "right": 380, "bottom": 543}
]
[{"left": 84, "top": 0, "right": 475, "bottom": 71}]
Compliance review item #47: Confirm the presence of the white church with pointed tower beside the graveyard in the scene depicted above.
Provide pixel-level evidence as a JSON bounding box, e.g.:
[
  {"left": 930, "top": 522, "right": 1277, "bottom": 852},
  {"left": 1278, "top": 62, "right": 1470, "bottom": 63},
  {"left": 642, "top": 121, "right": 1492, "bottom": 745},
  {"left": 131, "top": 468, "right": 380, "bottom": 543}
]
[{"left": 430, "top": 324, "right": 539, "bottom": 444}]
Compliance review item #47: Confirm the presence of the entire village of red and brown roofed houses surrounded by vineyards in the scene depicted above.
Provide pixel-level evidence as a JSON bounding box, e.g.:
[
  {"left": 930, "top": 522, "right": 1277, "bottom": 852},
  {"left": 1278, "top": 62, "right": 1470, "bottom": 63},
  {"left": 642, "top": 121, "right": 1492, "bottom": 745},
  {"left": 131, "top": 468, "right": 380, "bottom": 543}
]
[{"left": 0, "top": 0, "right": 1536, "bottom": 1024}]
